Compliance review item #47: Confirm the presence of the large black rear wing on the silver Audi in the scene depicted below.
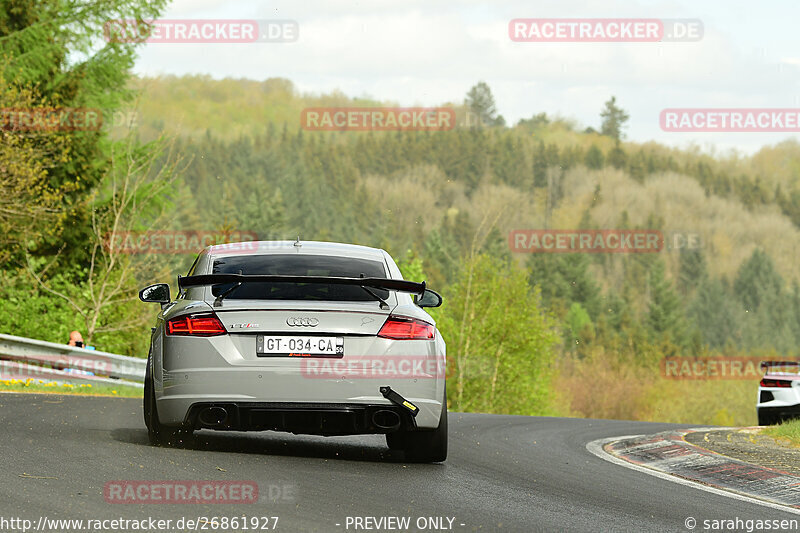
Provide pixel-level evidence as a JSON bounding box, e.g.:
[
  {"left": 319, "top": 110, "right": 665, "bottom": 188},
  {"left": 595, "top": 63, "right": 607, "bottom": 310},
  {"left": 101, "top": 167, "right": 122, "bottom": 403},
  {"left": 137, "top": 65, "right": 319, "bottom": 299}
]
[{"left": 178, "top": 274, "right": 425, "bottom": 295}]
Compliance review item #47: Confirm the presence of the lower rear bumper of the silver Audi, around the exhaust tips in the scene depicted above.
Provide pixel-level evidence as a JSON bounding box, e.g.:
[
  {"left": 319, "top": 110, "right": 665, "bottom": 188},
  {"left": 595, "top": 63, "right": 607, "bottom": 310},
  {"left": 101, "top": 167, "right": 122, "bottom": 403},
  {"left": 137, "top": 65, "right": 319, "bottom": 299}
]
[{"left": 156, "top": 368, "right": 444, "bottom": 435}]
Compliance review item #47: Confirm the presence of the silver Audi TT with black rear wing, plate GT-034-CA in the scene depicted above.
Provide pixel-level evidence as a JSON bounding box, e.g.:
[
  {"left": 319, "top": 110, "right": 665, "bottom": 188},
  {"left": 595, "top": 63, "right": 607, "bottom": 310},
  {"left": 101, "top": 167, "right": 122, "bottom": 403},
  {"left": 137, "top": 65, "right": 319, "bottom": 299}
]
[{"left": 139, "top": 239, "right": 447, "bottom": 462}]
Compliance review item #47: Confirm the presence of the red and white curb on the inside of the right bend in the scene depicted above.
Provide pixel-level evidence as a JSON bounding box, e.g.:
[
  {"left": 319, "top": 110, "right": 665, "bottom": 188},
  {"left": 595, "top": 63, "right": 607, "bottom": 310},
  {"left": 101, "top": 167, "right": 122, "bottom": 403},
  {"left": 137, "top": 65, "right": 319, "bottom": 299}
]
[{"left": 586, "top": 428, "right": 800, "bottom": 515}]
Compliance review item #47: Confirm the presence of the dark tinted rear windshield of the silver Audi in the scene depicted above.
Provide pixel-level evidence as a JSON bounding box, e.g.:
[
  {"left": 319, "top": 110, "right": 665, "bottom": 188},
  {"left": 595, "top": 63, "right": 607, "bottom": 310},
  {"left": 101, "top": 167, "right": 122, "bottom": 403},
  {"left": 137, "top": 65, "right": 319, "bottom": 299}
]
[{"left": 211, "top": 254, "right": 389, "bottom": 301}]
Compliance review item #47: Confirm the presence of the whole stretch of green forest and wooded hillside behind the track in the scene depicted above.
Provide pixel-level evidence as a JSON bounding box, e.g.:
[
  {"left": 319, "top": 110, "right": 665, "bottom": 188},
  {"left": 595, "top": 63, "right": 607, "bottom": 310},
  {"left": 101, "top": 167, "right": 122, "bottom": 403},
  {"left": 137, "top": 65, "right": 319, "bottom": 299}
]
[{"left": 0, "top": 2, "right": 800, "bottom": 424}]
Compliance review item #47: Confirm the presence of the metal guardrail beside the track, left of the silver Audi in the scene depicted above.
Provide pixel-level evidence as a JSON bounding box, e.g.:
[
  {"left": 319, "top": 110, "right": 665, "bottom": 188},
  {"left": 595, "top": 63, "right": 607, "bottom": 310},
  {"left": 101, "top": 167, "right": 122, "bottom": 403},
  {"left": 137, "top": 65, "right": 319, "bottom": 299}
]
[{"left": 0, "top": 334, "right": 147, "bottom": 387}]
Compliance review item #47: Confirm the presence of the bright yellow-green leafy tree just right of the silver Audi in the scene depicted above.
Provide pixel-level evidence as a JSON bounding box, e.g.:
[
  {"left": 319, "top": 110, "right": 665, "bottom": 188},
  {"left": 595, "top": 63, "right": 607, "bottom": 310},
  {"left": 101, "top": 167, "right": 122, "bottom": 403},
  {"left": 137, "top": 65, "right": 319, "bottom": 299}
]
[{"left": 436, "top": 255, "right": 558, "bottom": 415}]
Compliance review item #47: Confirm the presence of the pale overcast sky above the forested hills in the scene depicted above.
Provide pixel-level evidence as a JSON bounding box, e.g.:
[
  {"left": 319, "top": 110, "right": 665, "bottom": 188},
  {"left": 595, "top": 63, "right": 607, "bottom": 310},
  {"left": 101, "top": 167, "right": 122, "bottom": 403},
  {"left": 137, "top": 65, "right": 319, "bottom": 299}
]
[{"left": 131, "top": 0, "right": 800, "bottom": 153}]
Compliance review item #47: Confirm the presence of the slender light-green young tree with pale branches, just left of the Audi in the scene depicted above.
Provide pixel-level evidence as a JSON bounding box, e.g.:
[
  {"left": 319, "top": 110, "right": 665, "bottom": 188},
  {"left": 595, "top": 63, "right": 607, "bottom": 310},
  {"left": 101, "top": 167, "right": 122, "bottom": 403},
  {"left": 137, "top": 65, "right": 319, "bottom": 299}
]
[{"left": 26, "top": 134, "right": 179, "bottom": 344}]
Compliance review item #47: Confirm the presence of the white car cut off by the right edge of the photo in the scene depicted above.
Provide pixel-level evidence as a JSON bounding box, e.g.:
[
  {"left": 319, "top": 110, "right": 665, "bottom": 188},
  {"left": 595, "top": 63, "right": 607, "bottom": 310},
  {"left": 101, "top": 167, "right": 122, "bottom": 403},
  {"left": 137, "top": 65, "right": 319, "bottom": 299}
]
[{"left": 756, "top": 361, "right": 800, "bottom": 426}]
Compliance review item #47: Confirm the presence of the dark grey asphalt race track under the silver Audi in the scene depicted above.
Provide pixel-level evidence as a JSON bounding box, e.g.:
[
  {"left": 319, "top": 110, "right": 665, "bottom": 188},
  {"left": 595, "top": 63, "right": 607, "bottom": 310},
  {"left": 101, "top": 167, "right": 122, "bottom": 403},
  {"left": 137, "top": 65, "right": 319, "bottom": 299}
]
[{"left": 0, "top": 394, "right": 800, "bottom": 532}]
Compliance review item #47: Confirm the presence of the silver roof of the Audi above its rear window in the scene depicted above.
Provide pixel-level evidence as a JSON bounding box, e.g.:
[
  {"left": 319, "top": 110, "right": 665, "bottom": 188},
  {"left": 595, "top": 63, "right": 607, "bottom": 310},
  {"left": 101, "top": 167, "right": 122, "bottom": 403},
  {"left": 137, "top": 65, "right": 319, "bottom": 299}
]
[{"left": 204, "top": 241, "right": 385, "bottom": 261}]
